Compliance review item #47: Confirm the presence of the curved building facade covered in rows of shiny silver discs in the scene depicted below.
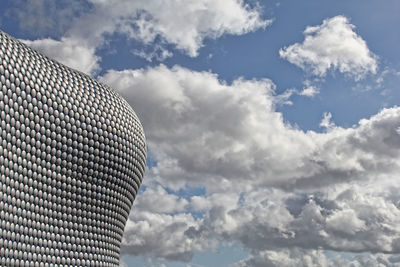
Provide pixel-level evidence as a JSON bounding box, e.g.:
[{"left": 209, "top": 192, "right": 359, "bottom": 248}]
[{"left": 0, "top": 31, "right": 146, "bottom": 266}]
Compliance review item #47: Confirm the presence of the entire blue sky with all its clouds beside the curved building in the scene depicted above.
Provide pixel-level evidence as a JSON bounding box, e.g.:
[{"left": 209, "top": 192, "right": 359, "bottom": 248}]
[{"left": 0, "top": 0, "right": 400, "bottom": 266}]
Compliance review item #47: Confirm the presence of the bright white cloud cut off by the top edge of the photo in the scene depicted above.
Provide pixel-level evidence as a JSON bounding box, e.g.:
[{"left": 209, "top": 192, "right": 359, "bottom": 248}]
[{"left": 85, "top": 0, "right": 271, "bottom": 57}]
